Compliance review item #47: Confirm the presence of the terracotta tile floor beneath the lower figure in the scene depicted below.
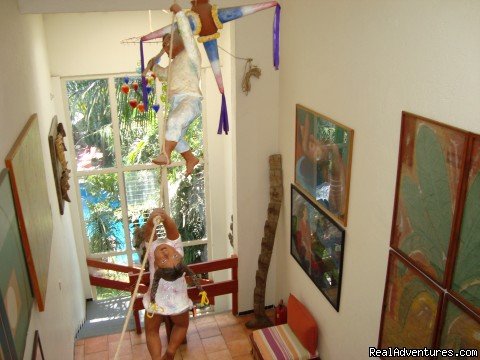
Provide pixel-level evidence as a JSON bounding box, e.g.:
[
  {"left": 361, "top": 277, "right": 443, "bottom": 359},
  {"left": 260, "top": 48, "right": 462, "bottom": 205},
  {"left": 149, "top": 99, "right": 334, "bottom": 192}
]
[{"left": 74, "top": 309, "right": 273, "bottom": 360}]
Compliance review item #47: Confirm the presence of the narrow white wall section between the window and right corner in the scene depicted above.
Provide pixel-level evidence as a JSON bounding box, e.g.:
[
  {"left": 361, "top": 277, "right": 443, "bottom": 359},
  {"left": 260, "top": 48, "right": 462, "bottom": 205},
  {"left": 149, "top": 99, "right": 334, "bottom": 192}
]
[{"left": 233, "top": 4, "right": 282, "bottom": 311}]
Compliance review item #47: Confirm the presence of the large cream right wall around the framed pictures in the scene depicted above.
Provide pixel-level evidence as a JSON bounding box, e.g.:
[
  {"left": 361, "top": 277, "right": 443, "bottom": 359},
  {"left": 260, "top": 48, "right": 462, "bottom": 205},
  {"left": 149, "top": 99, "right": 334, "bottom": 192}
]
[{"left": 277, "top": 0, "right": 480, "bottom": 360}]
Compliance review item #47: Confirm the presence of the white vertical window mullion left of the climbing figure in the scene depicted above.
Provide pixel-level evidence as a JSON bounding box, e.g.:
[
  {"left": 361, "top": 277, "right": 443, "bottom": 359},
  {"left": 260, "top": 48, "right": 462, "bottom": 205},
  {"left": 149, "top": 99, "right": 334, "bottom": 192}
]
[{"left": 108, "top": 77, "right": 133, "bottom": 265}]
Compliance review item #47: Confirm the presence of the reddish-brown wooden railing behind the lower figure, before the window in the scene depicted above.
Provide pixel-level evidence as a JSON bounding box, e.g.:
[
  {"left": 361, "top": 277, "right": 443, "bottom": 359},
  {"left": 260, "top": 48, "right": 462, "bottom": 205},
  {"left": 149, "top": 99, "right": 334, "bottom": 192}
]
[{"left": 87, "top": 256, "right": 238, "bottom": 332}]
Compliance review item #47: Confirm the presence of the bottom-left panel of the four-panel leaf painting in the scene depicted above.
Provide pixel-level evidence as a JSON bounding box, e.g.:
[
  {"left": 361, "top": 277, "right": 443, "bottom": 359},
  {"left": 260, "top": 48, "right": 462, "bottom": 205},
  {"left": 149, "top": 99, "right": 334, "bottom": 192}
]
[{"left": 378, "top": 249, "right": 443, "bottom": 359}]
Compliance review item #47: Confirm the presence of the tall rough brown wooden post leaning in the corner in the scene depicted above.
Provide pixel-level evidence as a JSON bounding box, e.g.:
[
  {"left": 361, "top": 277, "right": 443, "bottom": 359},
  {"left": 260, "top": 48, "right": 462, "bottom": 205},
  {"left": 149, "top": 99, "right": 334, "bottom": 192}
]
[{"left": 245, "top": 154, "right": 283, "bottom": 328}]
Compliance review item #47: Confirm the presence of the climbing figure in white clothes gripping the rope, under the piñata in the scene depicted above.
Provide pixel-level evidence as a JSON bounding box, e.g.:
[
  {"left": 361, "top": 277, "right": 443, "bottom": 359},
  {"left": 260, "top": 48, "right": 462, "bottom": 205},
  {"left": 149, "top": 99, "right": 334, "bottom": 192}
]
[{"left": 143, "top": 4, "right": 202, "bottom": 176}]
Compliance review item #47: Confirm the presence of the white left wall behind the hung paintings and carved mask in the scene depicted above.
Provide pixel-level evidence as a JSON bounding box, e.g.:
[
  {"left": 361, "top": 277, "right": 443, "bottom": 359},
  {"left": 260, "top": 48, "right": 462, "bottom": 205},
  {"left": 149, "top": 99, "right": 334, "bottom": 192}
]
[{"left": 0, "top": 0, "right": 85, "bottom": 359}]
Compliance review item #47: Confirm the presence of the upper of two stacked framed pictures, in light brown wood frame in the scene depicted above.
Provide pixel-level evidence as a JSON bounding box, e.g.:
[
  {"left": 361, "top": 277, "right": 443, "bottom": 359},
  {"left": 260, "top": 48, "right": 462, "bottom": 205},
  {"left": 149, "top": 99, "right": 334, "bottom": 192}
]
[{"left": 295, "top": 104, "right": 353, "bottom": 226}]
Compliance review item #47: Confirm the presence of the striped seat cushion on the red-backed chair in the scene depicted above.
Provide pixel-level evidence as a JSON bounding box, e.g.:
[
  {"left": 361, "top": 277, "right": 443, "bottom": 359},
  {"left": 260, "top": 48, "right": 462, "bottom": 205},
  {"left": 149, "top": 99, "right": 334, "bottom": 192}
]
[{"left": 252, "top": 324, "right": 311, "bottom": 360}]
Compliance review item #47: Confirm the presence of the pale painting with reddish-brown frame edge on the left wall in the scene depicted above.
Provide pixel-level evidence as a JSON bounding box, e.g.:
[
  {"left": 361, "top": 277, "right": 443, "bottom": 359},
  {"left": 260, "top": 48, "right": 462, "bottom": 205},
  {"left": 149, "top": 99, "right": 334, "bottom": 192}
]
[{"left": 5, "top": 114, "right": 53, "bottom": 311}]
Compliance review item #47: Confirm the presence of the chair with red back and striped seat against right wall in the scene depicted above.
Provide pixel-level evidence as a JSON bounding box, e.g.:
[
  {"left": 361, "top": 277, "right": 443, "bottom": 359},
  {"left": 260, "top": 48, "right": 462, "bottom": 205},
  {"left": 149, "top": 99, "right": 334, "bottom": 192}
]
[{"left": 250, "top": 294, "right": 319, "bottom": 360}]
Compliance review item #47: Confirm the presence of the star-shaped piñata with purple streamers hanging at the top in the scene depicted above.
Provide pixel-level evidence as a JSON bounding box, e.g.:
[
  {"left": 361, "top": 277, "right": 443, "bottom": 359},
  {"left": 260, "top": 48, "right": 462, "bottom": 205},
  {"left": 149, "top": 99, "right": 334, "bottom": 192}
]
[{"left": 140, "top": 0, "right": 280, "bottom": 134}]
